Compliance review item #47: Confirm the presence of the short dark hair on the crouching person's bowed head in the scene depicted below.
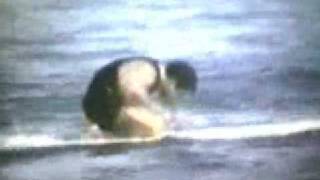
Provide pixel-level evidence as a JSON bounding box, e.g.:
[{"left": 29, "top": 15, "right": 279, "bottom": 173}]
[{"left": 166, "top": 60, "right": 198, "bottom": 92}]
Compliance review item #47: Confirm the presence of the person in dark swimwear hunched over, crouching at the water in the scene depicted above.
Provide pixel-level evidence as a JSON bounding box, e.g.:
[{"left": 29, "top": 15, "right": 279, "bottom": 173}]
[{"left": 82, "top": 57, "right": 197, "bottom": 137}]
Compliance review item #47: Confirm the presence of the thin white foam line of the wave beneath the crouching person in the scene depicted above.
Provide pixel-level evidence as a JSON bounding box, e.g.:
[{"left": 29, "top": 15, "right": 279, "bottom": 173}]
[{"left": 0, "top": 120, "right": 320, "bottom": 150}]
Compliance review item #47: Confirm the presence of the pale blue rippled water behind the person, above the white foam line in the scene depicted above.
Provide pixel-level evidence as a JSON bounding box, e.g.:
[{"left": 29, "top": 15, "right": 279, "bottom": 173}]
[{"left": 0, "top": 0, "right": 320, "bottom": 137}]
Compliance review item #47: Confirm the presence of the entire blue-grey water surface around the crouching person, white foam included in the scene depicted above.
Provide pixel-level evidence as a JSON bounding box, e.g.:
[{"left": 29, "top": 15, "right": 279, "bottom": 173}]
[{"left": 0, "top": 0, "right": 320, "bottom": 180}]
